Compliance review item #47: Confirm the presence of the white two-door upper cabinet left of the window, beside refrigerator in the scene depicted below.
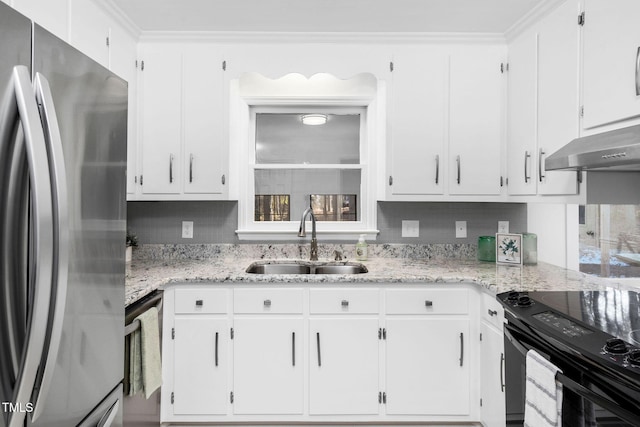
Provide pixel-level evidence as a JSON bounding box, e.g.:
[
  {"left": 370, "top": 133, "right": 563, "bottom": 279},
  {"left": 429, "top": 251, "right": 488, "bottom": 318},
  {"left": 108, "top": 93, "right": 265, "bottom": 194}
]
[{"left": 140, "top": 43, "right": 229, "bottom": 200}]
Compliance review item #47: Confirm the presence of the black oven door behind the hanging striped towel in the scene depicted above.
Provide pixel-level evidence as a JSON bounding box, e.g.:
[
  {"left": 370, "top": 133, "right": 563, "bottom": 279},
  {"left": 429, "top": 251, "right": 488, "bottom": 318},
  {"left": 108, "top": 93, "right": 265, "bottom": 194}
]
[{"left": 504, "top": 320, "right": 640, "bottom": 427}]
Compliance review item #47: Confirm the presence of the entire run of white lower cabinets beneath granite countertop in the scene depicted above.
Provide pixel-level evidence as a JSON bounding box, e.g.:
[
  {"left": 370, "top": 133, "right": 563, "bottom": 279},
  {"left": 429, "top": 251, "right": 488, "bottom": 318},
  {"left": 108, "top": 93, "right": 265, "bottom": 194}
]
[{"left": 161, "top": 283, "right": 504, "bottom": 427}]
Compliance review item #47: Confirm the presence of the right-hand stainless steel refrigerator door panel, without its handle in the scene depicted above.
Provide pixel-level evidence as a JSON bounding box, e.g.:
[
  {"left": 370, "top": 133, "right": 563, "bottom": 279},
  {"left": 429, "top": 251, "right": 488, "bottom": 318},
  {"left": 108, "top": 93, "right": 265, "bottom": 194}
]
[{"left": 27, "top": 25, "right": 127, "bottom": 427}]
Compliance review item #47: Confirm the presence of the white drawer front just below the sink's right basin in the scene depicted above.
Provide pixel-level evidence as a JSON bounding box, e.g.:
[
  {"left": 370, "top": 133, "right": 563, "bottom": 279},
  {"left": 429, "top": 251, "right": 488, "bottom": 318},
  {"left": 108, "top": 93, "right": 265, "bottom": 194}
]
[{"left": 309, "top": 289, "right": 380, "bottom": 314}]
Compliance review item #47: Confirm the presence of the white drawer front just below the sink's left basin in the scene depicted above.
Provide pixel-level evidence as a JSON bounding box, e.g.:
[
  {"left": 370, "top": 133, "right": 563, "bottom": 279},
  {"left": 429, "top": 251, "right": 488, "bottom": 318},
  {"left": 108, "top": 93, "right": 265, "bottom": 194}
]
[{"left": 233, "top": 289, "right": 303, "bottom": 314}]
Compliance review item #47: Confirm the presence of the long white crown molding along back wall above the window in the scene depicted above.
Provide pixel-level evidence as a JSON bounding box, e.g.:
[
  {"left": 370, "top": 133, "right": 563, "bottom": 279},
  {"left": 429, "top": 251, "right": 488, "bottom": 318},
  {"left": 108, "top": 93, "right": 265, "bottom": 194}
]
[{"left": 140, "top": 31, "right": 506, "bottom": 44}]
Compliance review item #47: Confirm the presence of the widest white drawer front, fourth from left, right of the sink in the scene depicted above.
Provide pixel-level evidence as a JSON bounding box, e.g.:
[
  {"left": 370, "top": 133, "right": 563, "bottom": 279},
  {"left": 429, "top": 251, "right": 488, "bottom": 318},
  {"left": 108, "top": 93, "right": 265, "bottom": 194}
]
[{"left": 386, "top": 289, "right": 469, "bottom": 314}]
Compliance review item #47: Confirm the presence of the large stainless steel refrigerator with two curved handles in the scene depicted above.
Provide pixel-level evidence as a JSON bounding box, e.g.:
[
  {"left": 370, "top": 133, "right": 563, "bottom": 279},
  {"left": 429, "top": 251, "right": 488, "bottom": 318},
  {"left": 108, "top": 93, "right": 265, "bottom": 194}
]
[{"left": 0, "top": 2, "right": 127, "bottom": 427}]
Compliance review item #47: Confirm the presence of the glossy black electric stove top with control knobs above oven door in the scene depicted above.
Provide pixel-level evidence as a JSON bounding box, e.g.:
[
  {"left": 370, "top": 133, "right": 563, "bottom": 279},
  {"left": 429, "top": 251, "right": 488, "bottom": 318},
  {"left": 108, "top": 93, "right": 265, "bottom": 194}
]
[{"left": 497, "top": 289, "right": 640, "bottom": 426}]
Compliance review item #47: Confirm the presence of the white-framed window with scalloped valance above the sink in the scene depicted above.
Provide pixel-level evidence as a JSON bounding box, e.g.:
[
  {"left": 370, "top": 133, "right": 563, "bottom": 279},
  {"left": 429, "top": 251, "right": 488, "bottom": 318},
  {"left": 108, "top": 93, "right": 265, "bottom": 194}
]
[{"left": 231, "top": 73, "right": 384, "bottom": 241}]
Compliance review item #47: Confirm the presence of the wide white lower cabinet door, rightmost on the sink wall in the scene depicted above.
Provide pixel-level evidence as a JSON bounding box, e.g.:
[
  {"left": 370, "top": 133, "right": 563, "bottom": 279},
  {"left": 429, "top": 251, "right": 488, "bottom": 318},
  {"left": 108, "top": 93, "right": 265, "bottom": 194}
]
[{"left": 386, "top": 317, "right": 474, "bottom": 415}]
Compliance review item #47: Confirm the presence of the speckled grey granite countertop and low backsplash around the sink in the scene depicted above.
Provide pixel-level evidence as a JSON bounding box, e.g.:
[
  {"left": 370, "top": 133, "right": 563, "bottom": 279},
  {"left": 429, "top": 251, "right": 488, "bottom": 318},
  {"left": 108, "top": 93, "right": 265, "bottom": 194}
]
[{"left": 125, "top": 245, "right": 629, "bottom": 305}]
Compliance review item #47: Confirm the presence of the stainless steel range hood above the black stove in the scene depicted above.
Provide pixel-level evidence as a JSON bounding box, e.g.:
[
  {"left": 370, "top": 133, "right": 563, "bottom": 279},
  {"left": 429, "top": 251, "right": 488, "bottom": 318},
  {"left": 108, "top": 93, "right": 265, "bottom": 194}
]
[{"left": 545, "top": 125, "right": 640, "bottom": 172}]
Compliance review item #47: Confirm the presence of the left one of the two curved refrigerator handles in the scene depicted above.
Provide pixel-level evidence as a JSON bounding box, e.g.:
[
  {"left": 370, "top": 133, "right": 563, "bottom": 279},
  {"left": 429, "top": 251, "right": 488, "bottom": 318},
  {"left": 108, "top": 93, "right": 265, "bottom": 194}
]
[{"left": 8, "top": 65, "right": 53, "bottom": 427}]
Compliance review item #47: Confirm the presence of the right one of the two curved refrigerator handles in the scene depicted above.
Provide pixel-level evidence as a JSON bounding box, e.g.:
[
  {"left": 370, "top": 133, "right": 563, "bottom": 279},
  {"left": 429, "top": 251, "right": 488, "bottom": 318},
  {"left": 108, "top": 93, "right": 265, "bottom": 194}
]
[{"left": 31, "top": 73, "right": 69, "bottom": 421}]
